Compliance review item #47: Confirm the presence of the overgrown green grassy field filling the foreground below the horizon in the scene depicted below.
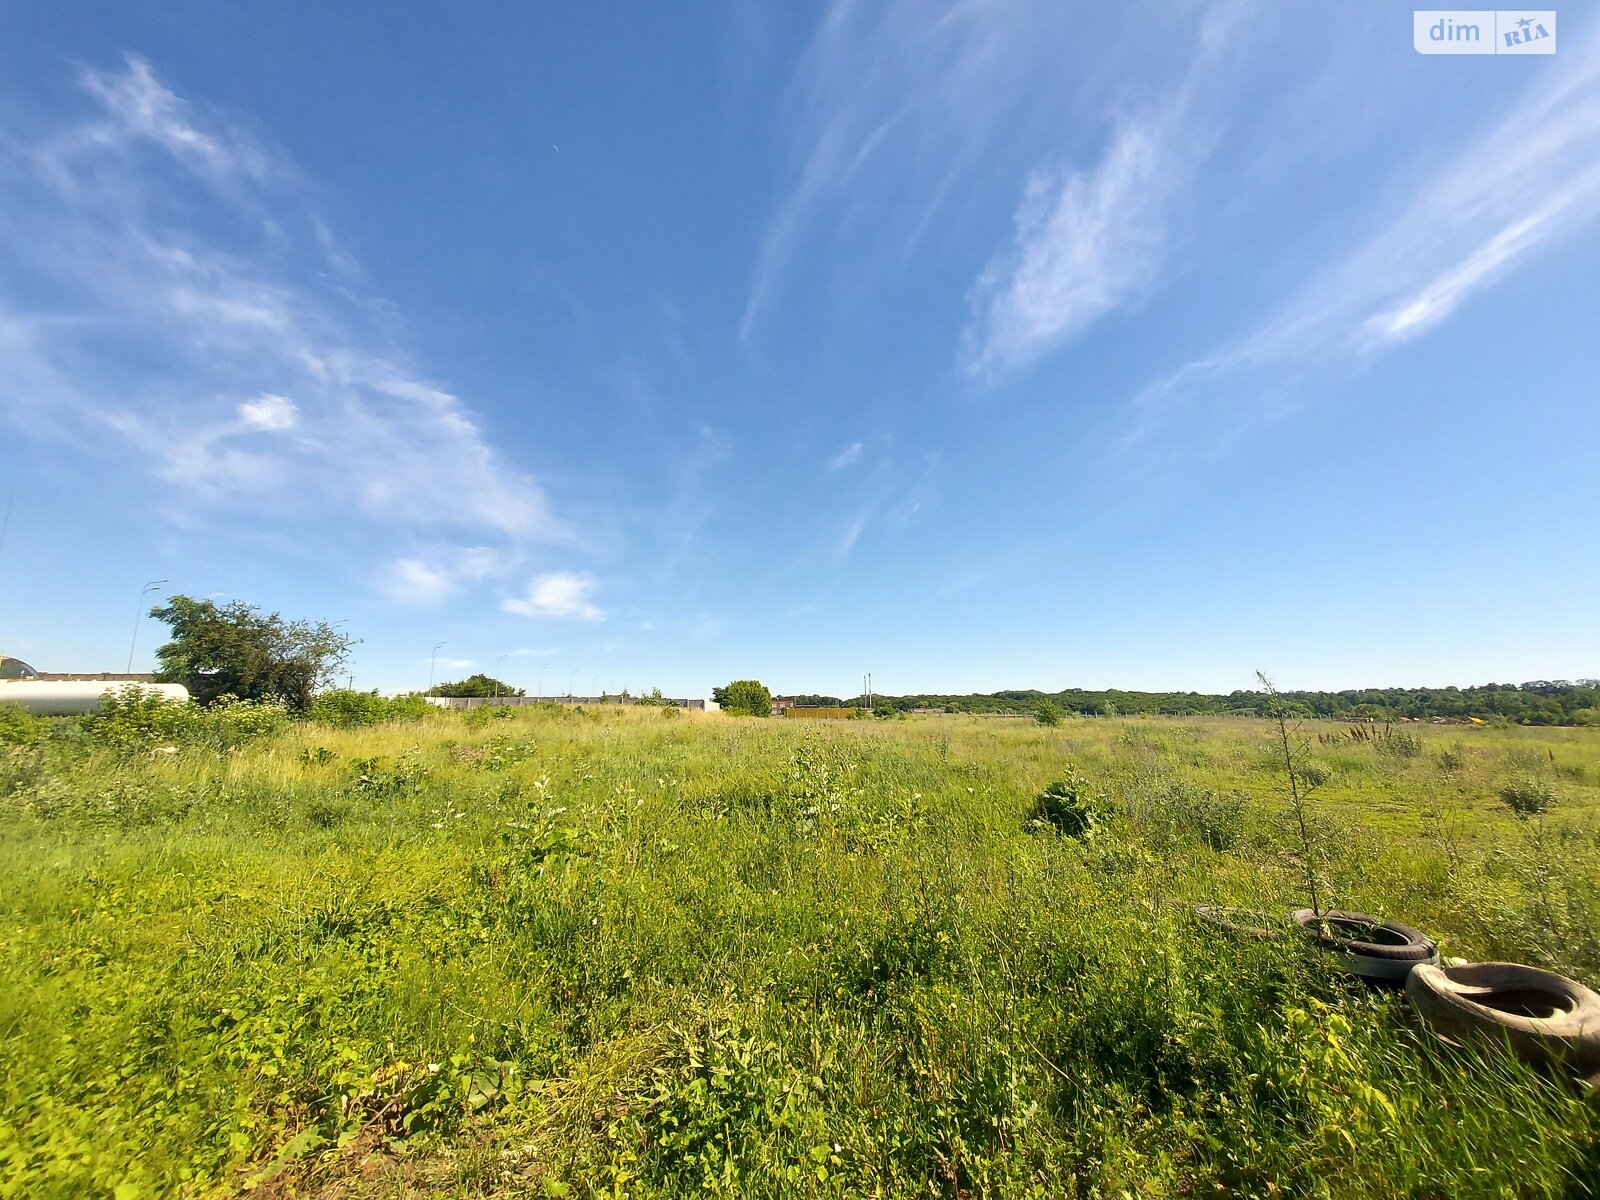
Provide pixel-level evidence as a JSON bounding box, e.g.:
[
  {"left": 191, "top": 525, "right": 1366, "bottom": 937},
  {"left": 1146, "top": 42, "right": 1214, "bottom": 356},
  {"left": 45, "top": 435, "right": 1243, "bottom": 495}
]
[{"left": 0, "top": 710, "right": 1600, "bottom": 1200}]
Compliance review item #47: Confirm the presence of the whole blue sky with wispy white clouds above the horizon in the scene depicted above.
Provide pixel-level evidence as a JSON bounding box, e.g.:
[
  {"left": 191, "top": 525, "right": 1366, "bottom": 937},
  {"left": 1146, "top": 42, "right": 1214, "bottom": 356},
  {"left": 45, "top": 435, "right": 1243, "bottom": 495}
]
[{"left": 0, "top": 0, "right": 1600, "bottom": 696}]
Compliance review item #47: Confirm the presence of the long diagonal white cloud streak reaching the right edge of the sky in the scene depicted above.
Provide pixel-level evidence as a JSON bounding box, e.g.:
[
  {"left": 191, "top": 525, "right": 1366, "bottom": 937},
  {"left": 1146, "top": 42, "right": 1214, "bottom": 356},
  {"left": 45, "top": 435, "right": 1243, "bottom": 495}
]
[{"left": 1131, "top": 21, "right": 1600, "bottom": 440}]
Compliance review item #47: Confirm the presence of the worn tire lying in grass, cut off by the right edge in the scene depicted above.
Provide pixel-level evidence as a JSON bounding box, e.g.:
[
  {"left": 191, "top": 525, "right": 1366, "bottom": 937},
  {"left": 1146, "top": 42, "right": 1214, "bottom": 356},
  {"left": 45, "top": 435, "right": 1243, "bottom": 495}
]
[{"left": 1405, "top": 963, "right": 1600, "bottom": 1072}]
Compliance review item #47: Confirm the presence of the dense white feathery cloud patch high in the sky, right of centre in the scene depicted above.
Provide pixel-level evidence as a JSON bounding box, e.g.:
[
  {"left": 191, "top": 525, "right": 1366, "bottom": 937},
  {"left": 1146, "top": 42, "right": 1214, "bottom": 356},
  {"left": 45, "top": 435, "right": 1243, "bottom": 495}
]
[{"left": 966, "top": 118, "right": 1190, "bottom": 376}]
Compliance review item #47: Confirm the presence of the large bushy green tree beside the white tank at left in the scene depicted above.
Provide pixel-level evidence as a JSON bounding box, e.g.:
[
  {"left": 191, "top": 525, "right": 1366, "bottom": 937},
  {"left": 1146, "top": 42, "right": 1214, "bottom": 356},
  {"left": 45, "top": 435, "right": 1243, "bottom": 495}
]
[{"left": 150, "top": 595, "right": 355, "bottom": 710}]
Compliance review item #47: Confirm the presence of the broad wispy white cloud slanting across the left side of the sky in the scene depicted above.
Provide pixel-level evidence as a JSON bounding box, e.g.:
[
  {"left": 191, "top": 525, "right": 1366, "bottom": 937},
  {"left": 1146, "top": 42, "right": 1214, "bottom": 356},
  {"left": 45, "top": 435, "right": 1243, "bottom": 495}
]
[{"left": 0, "top": 56, "right": 571, "bottom": 600}]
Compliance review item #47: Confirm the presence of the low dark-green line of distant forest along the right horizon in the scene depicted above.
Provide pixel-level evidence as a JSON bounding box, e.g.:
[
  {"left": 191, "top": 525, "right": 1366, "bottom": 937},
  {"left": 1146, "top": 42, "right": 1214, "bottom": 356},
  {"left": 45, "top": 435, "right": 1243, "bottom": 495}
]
[{"left": 794, "top": 678, "right": 1600, "bottom": 725}]
